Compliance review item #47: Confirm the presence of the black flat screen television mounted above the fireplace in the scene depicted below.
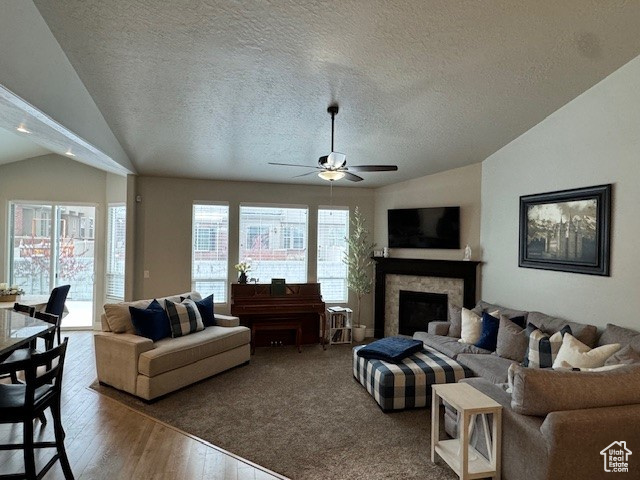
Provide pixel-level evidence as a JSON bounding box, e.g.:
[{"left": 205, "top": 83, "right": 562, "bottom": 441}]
[{"left": 387, "top": 207, "right": 460, "bottom": 249}]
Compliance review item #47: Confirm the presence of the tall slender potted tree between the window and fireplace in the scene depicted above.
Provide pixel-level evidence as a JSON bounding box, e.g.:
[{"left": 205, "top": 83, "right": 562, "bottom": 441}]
[{"left": 343, "top": 207, "right": 376, "bottom": 342}]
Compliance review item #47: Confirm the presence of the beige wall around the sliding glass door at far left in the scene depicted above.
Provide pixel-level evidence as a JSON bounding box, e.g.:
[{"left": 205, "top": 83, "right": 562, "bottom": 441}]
[{"left": 0, "top": 154, "right": 126, "bottom": 324}]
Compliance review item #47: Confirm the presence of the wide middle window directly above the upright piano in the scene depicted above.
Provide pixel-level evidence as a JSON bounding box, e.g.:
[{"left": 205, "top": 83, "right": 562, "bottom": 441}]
[{"left": 240, "top": 206, "right": 308, "bottom": 283}]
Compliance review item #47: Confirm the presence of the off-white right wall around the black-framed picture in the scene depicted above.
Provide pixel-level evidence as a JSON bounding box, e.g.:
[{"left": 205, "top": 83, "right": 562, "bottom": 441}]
[{"left": 481, "top": 53, "right": 640, "bottom": 328}]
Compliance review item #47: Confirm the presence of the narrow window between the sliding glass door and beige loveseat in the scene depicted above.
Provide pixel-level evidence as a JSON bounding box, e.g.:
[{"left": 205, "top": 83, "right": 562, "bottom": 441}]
[{"left": 106, "top": 205, "right": 127, "bottom": 301}]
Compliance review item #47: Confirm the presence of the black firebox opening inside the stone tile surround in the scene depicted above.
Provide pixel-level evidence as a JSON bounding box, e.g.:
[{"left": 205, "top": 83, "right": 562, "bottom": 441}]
[{"left": 398, "top": 290, "right": 448, "bottom": 336}]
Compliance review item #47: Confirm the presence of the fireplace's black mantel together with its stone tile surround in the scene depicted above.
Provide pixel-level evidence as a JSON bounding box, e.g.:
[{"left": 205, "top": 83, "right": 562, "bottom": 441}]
[{"left": 374, "top": 257, "right": 480, "bottom": 338}]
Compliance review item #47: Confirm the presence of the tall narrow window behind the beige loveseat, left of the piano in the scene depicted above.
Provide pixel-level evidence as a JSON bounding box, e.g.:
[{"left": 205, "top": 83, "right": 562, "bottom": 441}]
[{"left": 191, "top": 204, "right": 229, "bottom": 303}]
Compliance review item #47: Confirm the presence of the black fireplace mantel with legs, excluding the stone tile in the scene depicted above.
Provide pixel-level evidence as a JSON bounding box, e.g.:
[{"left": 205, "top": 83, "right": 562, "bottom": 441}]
[{"left": 373, "top": 257, "right": 481, "bottom": 338}]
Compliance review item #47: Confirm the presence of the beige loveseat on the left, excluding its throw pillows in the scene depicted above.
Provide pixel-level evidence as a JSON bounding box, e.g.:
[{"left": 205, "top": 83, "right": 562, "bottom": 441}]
[{"left": 94, "top": 292, "right": 251, "bottom": 400}]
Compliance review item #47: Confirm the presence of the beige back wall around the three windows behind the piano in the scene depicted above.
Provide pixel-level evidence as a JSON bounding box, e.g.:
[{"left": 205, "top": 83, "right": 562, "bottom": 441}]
[{"left": 132, "top": 176, "right": 374, "bottom": 327}]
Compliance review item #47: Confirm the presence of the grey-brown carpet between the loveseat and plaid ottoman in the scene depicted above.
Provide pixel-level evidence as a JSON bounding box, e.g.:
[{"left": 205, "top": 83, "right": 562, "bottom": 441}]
[{"left": 91, "top": 345, "right": 457, "bottom": 480}]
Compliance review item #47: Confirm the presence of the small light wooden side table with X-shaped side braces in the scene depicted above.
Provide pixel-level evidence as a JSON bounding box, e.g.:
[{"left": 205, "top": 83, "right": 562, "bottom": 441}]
[{"left": 431, "top": 383, "right": 502, "bottom": 480}]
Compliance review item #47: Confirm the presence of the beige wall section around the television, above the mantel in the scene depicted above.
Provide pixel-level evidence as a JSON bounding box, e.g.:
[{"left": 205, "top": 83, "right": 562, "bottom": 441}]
[{"left": 374, "top": 163, "right": 482, "bottom": 260}]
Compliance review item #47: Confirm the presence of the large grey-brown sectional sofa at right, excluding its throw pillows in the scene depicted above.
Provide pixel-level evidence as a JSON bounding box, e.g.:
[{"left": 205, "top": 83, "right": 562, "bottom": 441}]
[{"left": 414, "top": 302, "right": 640, "bottom": 480}]
